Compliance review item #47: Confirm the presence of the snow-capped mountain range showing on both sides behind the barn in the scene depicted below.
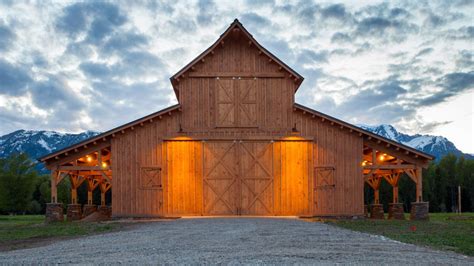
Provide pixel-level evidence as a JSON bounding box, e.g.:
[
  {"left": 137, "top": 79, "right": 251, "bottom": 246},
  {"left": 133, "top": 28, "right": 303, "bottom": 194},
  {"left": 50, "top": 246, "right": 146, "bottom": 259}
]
[{"left": 0, "top": 125, "right": 474, "bottom": 172}]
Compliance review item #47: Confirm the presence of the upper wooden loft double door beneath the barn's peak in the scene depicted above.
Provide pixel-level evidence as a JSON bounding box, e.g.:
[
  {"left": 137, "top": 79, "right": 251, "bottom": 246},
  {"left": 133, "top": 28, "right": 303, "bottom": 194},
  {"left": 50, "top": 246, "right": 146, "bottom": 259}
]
[{"left": 215, "top": 78, "right": 258, "bottom": 127}]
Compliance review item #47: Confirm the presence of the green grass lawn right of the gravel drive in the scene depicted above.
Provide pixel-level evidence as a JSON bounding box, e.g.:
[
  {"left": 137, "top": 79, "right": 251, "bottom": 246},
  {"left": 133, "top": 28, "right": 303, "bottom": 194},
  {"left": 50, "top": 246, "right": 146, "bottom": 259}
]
[{"left": 329, "top": 213, "right": 474, "bottom": 256}]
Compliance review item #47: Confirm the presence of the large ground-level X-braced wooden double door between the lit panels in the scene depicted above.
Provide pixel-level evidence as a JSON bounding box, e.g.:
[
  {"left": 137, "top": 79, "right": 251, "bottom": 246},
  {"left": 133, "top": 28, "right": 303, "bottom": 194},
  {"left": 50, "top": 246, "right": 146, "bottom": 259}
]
[{"left": 203, "top": 141, "right": 274, "bottom": 215}]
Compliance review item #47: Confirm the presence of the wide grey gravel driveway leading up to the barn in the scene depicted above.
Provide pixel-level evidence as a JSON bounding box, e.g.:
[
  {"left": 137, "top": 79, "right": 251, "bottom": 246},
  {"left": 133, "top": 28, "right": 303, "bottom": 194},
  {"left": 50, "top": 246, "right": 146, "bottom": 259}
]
[{"left": 0, "top": 218, "right": 474, "bottom": 265}]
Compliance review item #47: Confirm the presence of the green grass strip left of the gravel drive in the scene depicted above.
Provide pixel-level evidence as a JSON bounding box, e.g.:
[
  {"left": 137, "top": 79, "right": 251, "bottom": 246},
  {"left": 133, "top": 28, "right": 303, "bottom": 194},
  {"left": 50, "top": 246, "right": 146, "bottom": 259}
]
[{"left": 0, "top": 215, "right": 121, "bottom": 250}]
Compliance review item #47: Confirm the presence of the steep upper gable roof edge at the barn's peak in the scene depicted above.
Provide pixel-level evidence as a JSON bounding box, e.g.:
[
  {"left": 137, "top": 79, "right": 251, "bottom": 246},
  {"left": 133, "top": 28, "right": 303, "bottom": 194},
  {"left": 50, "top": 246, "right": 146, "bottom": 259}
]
[{"left": 170, "top": 19, "right": 304, "bottom": 99}]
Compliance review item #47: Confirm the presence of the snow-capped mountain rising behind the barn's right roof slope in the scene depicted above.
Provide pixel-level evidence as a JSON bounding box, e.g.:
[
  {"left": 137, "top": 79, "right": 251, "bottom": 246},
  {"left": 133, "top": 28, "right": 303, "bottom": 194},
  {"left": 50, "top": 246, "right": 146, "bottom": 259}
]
[{"left": 358, "top": 125, "right": 474, "bottom": 160}]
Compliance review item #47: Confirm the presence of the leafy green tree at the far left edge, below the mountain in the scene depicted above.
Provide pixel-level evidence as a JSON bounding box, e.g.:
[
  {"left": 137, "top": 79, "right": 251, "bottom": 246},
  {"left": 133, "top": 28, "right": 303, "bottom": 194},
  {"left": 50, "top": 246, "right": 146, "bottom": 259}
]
[{"left": 0, "top": 154, "right": 38, "bottom": 213}]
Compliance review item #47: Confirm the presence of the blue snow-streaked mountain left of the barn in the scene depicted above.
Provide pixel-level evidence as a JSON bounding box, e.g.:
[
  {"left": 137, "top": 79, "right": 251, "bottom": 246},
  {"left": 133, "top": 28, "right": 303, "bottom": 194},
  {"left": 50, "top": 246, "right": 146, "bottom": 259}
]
[{"left": 0, "top": 130, "right": 99, "bottom": 162}]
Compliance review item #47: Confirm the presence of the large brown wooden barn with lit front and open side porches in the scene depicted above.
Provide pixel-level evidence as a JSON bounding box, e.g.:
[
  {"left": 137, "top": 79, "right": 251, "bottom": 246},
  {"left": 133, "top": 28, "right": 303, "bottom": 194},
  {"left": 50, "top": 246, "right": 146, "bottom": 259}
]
[{"left": 41, "top": 20, "right": 433, "bottom": 220}]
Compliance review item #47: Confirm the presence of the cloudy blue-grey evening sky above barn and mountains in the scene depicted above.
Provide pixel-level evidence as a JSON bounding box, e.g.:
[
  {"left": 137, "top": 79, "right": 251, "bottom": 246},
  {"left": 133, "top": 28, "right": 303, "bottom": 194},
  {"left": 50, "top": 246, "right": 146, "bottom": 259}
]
[{"left": 0, "top": 0, "right": 474, "bottom": 153}]
